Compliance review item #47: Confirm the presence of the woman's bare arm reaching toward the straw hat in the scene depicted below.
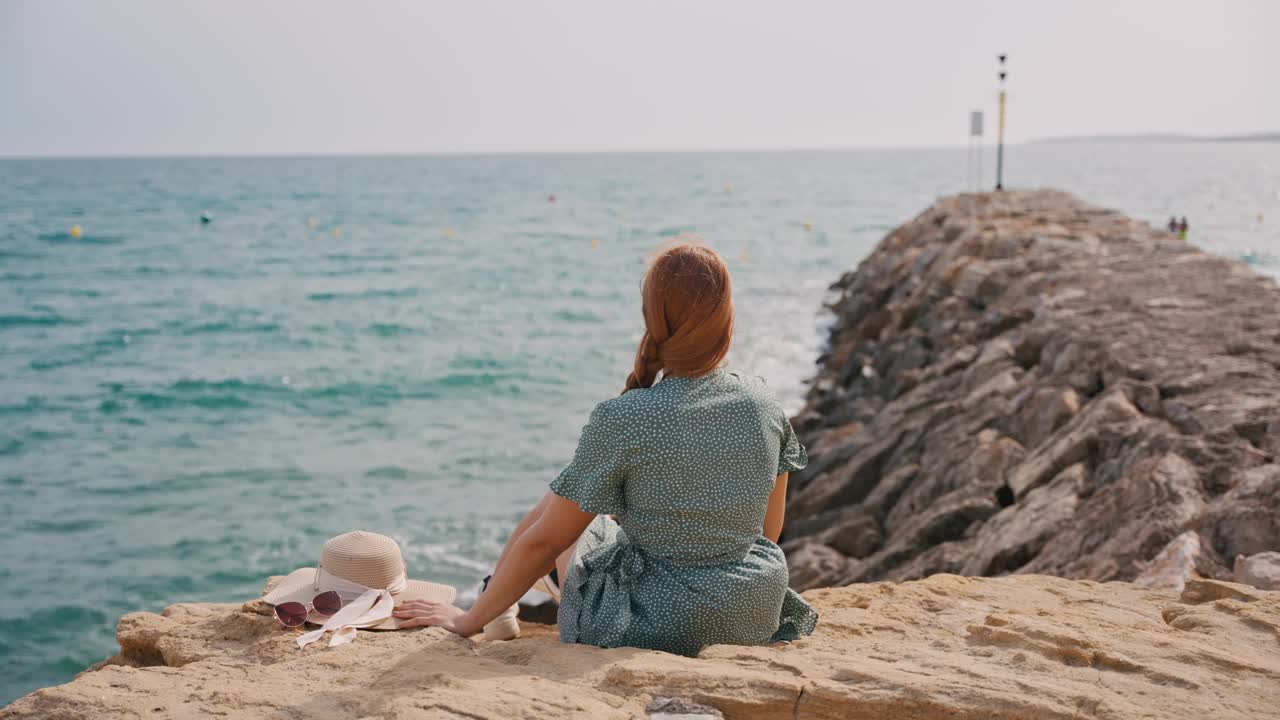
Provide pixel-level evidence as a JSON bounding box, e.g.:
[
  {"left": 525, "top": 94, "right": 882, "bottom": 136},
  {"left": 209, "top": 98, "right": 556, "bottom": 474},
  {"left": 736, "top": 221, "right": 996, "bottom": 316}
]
[{"left": 397, "top": 493, "right": 595, "bottom": 638}]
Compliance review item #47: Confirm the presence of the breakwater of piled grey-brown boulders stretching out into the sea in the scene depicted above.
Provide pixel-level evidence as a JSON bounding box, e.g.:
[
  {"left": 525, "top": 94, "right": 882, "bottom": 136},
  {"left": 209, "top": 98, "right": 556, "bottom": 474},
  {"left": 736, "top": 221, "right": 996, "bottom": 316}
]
[{"left": 783, "top": 191, "right": 1280, "bottom": 589}]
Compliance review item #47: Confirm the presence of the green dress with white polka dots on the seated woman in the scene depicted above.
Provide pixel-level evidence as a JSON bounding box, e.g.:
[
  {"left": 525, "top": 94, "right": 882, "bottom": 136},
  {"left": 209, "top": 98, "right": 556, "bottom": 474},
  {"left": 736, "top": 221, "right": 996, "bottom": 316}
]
[{"left": 552, "top": 369, "right": 818, "bottom": 656}]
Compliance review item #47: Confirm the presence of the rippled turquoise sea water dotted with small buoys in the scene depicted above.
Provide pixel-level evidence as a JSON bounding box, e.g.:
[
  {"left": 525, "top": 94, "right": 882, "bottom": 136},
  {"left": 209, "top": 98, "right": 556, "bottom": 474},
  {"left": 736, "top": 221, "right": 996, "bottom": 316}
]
[{"left": 0, "top": 145, "right": 1280, "bottom": 703}]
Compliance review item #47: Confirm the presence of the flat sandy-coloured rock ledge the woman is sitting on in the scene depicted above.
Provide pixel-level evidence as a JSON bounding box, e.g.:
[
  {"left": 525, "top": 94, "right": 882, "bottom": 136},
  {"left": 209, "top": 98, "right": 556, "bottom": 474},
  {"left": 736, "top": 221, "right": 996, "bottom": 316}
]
[{"left": 0, "top": 575, "right": 1280, "bottom": 720}]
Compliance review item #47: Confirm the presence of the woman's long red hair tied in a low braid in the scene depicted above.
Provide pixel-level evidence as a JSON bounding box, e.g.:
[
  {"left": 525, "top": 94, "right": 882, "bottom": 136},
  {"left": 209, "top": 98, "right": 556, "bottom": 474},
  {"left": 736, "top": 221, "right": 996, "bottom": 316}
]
[{"left": 622, "top": 241, "right": 733, "bottom": 393}]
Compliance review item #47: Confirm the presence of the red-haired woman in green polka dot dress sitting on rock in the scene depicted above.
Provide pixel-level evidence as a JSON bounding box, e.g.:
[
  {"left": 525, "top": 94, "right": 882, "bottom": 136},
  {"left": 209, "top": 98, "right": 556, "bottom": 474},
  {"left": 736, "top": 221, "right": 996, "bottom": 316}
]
[{"left": 396, "top": 242, "right": 818, "bottom": 655}]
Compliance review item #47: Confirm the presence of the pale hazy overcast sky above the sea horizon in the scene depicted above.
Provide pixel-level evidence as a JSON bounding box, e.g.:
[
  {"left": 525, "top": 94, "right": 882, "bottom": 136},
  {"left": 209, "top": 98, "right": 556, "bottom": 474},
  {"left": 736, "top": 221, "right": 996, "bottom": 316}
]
[{"left": 0, "top": 0, "right": 1280, "bottom": 155}]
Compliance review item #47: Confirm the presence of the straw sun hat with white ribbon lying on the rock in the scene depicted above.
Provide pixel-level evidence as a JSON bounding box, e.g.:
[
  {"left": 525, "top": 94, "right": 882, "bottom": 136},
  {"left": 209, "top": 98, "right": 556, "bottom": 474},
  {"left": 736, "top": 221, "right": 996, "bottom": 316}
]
[{"left": 262, "top": 530, "right": 458, "bottom": 630}]
